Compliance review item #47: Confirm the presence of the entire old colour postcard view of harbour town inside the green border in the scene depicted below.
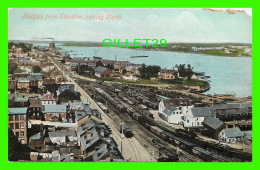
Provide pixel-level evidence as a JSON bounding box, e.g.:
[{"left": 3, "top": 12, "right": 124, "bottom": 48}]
[{"left": 7, "top": 8, "right": 252, "bottom": 162}]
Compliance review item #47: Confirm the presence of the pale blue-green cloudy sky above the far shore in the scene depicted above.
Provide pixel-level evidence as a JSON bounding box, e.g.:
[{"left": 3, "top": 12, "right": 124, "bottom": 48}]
[{"left": 8, "top": 8, "right": 252, "bottom": 43}]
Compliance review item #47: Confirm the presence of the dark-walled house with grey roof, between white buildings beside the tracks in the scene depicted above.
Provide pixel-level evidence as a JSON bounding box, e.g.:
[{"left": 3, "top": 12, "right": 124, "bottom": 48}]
[{"left": 203, "top": 117, "right": 225, "bottom": 139}]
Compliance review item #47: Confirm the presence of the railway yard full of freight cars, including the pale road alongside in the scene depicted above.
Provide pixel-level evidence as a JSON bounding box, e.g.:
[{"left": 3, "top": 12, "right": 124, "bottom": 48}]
[{"left": 49, "top": 57, "right": 252, "bottom": 162}]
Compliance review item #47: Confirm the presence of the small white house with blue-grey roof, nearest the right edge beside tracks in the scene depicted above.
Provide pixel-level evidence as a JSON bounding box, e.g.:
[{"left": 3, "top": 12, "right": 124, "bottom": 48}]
[{"left": 219, "top": 127, "right": 244, "bottom": 143}]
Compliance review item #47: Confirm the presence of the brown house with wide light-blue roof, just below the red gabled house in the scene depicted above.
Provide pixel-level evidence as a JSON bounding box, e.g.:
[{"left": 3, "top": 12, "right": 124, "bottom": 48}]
[{"left": 42, "top": 104, "right": 67, "bottom": 122}]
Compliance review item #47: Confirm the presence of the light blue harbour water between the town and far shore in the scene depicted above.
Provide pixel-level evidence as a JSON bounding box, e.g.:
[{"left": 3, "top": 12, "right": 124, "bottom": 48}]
[{"left": 39, "top": 44, "right": 252, "bottom": 97}]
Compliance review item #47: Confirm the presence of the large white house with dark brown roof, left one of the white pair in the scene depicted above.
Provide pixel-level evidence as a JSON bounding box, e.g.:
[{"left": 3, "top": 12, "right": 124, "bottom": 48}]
[{"left": 158, "top": 98, "right": 193, "bottom": 124}]
